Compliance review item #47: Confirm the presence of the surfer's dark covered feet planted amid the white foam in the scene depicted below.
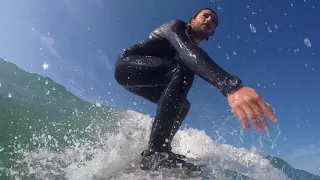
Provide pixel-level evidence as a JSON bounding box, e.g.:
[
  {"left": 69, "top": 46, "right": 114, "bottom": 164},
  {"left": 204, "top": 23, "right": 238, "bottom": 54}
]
[{"left": 140, "top": 151, "right": 200, "bottom": 171}]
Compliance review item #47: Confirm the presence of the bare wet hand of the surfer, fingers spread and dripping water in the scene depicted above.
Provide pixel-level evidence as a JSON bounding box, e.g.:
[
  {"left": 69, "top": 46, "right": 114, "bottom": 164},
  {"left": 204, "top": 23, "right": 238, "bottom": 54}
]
[{"left": 228, "top": 87, "right": 277, "bottom": 131}]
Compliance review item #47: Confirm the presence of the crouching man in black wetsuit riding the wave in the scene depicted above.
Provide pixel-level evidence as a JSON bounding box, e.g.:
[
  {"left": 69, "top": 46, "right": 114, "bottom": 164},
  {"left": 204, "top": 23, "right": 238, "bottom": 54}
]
[{"left": 115, "top": 8, "right": 277, "bottom": 170}]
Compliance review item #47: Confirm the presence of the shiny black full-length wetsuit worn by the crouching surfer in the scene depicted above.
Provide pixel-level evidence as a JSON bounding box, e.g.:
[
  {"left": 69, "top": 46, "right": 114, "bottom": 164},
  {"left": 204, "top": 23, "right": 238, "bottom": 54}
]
[{"left": 115, "top": 20, "right": 241, "bottom": 158}]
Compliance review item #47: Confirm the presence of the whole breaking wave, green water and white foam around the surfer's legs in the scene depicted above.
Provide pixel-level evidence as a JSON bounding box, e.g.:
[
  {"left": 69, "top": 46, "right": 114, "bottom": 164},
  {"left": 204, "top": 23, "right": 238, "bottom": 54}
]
[{"left": 0, "top": 59, "right": 320, "bottom": 180}]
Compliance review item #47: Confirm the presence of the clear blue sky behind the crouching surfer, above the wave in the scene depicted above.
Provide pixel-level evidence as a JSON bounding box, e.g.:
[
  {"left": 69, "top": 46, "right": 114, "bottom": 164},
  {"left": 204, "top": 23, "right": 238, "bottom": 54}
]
[{"left": 0, "top": 0, "right": 320, "bottom": 174}]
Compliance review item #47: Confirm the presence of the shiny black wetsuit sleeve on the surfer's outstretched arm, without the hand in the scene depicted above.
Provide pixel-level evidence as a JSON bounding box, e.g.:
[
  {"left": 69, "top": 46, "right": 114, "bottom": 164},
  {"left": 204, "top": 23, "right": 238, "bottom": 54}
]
[{"left": 160, "top": 20, "right": 242, "bottom": 96}]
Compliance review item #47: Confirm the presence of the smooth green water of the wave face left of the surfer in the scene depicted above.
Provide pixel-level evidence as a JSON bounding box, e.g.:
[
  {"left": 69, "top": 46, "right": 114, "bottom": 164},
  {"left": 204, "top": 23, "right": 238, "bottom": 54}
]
[{"left": 0, "top": 59, "right": 125, "bottom": 179}]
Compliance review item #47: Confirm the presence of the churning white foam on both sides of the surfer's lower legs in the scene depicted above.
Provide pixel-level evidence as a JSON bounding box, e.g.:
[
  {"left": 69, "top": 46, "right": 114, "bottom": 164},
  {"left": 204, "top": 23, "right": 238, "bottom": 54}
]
[{"left": 12, "top": 111, "right": 288, "bottom": 180}]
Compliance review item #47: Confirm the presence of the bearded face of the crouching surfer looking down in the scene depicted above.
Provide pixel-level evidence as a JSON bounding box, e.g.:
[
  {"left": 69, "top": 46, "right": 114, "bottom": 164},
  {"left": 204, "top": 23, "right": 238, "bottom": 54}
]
[{"left": 191, "top": 9, "right": 217, "bottom": 37}]
